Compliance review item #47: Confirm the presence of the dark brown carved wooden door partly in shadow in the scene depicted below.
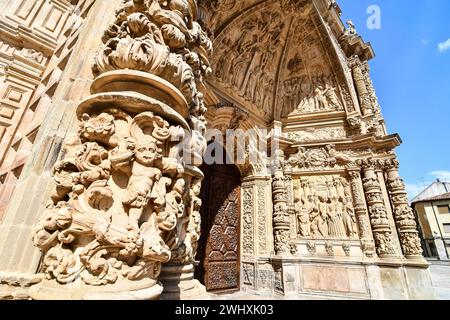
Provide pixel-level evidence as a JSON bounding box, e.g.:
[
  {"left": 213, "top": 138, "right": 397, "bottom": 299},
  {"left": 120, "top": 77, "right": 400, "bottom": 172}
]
[{"left": 197, "top": 165, "right": 240, "bottom": 292}]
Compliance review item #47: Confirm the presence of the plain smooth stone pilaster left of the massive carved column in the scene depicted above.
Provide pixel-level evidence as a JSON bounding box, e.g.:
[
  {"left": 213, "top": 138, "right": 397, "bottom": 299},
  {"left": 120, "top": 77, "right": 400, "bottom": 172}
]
[{"left": 0, "top": 0, "right": 120, "bottom": 298}]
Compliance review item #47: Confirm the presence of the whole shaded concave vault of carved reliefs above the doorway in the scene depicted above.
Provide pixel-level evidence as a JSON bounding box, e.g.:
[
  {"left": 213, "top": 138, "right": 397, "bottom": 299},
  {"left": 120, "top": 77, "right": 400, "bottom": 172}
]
[{"left": 204, "top": 1, "right": 344, "bottom": 121}]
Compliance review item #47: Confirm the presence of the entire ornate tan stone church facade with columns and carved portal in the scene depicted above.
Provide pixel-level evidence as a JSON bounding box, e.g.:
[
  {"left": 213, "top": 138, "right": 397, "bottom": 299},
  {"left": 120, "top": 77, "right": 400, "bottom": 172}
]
[{"left": 0, "top": 0, "right": 433, "bottom": 299}]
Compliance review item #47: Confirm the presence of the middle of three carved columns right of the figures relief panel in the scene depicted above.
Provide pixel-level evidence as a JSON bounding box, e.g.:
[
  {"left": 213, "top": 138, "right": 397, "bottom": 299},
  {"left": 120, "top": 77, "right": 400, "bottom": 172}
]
[{"left": 361, "top": 160, "right": 396, "bottom": 258}]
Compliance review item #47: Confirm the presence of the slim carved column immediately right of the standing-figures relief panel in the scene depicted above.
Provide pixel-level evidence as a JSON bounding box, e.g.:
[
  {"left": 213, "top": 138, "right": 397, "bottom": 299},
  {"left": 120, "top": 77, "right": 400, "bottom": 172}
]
[{"left": 347, "top": 167, "right": 375, "bottom": 258}]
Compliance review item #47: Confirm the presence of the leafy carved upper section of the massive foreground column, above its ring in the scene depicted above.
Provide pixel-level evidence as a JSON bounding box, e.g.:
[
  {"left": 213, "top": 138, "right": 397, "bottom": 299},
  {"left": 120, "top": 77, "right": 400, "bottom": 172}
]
[{"left": 93, "top": 0, "right": 212, "bottom": 127}]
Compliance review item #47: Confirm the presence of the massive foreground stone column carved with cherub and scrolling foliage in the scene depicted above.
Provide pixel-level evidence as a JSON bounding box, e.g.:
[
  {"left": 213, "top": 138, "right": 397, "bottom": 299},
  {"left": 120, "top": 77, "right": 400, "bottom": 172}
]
[{"left": 30, "top": 0, "right": 212, "bottom": 299}]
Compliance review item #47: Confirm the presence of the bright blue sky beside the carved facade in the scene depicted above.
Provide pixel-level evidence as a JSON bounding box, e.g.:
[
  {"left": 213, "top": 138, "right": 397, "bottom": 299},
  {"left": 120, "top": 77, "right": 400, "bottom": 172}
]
[{"left": 338, "top": 0, "right": 450, "bottom": 197}]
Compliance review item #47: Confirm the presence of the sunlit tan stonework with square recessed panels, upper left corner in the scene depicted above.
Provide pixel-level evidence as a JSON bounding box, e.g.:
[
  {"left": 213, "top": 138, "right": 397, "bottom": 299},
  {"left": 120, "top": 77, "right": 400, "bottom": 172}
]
[{"left": 0, "top": 0, "right": 93, "bottom": 220}]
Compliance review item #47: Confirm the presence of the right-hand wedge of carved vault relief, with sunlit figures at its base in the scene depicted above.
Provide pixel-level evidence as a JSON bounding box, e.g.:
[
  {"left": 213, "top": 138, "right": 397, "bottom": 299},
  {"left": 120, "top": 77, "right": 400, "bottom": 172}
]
[{"left": 277, "top": 15, "right": 344, "bottom": 117}]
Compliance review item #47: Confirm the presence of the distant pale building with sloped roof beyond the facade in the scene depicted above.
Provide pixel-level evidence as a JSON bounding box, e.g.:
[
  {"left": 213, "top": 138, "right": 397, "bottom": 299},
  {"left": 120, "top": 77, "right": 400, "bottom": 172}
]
[{"left": 412, "top": 180, "right": 450, "bottom": 260}]
